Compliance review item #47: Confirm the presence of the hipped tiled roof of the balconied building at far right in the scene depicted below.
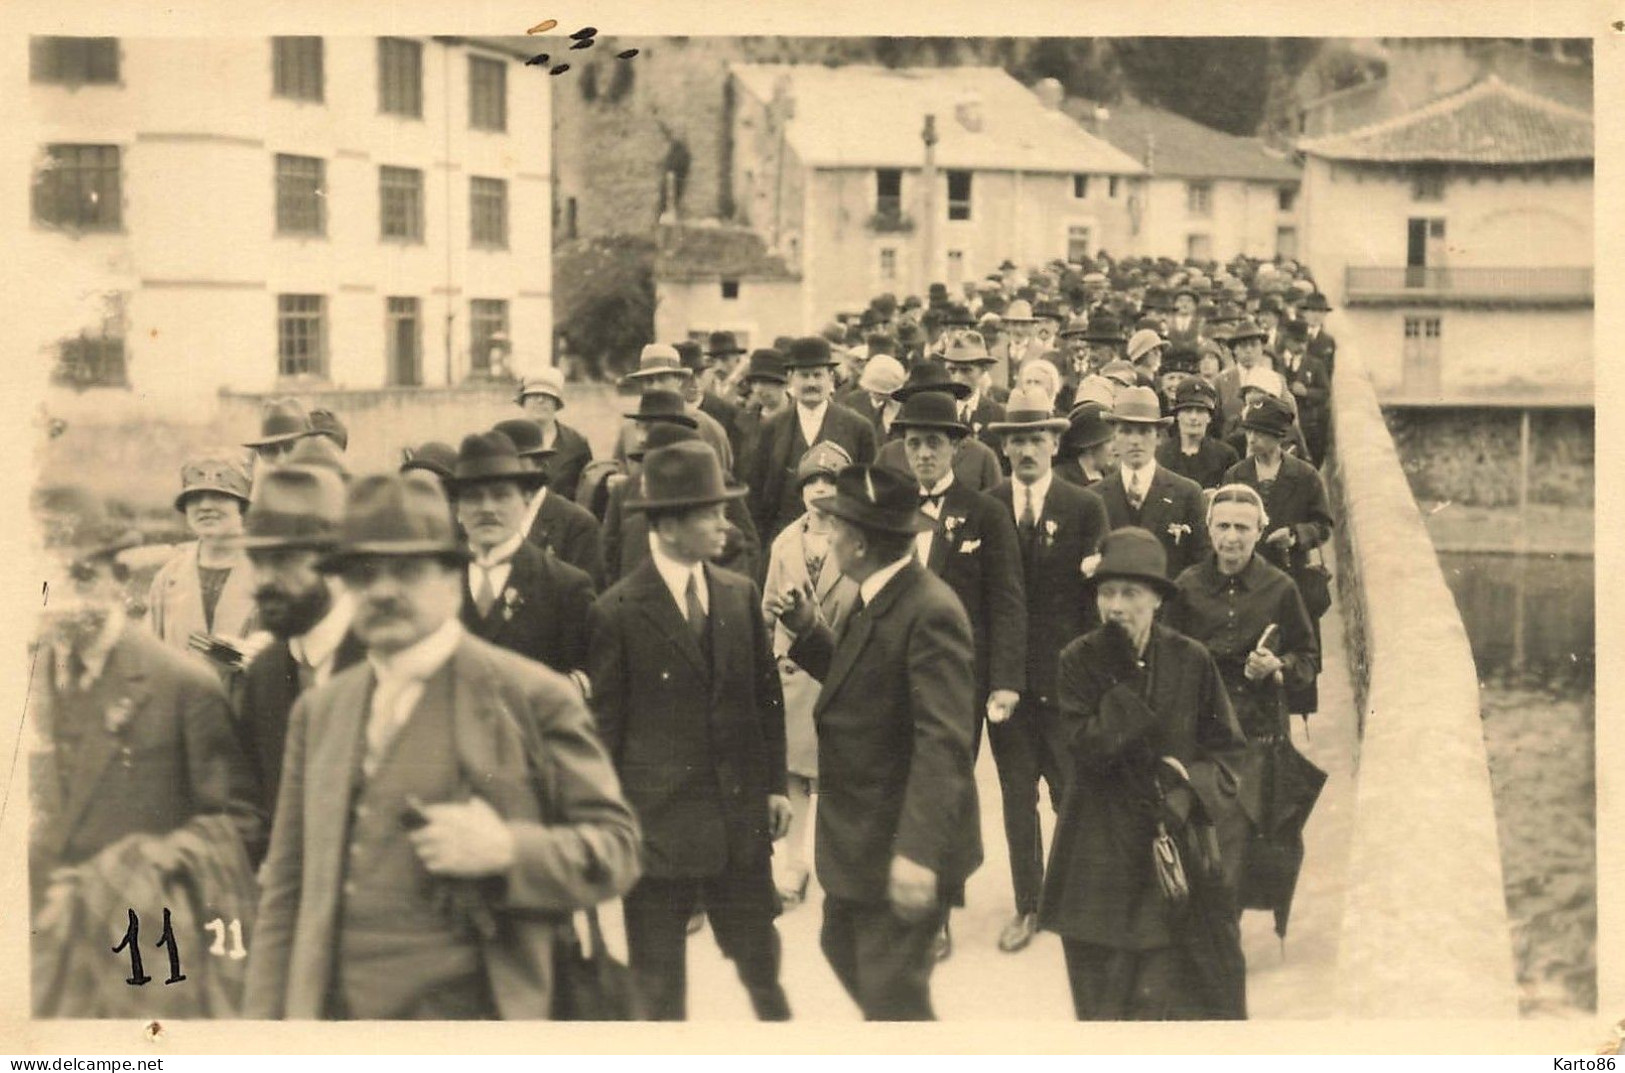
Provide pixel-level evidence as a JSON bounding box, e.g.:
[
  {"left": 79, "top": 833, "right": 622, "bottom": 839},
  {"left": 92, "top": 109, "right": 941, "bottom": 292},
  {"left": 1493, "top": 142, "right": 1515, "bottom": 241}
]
[{"left": 1298, "top": 75, "right": 1594, "bottom": 164}]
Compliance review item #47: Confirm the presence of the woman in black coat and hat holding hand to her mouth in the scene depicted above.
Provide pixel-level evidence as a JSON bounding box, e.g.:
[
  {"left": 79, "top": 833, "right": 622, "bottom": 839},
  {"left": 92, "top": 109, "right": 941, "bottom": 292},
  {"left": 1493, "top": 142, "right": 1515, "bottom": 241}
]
[{"left": 1038, "top": 528, "right": 1246, "bottom": 1021}]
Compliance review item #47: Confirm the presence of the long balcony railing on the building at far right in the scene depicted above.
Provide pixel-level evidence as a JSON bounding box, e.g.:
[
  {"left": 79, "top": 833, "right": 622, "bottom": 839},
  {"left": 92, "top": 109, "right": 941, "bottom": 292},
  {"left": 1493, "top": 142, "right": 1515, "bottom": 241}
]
[{"left": 1344, "top": 265, "right": 1594, "bottom": 306}]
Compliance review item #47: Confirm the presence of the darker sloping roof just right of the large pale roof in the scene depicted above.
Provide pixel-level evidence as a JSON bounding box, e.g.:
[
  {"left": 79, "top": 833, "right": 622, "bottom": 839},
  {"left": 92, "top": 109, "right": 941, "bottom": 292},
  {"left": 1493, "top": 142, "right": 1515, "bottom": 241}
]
[{"left": 1064, "top": 99, "right": 1302, "bottom": 182}]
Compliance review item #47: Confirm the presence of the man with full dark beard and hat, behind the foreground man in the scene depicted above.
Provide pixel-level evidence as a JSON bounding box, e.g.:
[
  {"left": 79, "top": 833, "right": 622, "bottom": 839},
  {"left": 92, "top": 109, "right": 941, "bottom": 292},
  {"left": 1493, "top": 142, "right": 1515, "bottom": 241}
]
[{"left": 237, "top": 458, "right": 366, "bottom": 816}]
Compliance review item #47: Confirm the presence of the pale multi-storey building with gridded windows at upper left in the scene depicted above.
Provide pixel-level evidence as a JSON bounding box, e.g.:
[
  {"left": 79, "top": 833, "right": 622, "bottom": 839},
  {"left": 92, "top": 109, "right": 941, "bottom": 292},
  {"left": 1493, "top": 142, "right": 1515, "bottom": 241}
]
[{"left": 11, "top": 37, "right": 553, "bottom": 411}]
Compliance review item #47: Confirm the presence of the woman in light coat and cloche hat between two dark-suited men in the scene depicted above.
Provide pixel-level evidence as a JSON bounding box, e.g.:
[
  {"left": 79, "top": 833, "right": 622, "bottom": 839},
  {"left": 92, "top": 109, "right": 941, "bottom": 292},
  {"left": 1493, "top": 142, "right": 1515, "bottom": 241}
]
[{"left": 762, "top": 441, "right": 858, "bottom": 909}]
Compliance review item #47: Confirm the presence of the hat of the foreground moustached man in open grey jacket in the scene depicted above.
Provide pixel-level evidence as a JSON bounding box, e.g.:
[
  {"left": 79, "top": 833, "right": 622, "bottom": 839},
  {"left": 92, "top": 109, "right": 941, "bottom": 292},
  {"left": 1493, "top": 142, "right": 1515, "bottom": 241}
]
[{"left": 320, "top": 473, "right": 468, "bottom": 572}]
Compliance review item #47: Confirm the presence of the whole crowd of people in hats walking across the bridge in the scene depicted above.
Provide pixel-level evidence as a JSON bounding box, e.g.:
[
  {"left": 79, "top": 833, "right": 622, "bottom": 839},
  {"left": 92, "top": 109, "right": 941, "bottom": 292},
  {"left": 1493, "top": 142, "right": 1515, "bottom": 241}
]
[{"left": 31, "top": 248, "right": 1336, "bottom": 1019}]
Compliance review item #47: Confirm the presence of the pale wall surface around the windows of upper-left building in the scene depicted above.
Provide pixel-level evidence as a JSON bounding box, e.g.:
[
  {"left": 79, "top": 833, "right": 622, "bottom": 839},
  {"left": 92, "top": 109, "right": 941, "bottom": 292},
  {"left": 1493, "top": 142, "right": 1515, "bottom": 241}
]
[{"left": 20, "top": 37, "right": 553, "bottom": 411}]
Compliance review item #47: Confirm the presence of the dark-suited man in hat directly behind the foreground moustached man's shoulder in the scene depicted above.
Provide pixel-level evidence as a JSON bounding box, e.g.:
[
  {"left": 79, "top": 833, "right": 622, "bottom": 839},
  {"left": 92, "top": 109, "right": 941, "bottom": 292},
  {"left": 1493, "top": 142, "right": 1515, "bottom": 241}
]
[{"left": 447, "top": 432, "right": 593, "bottom": 684}]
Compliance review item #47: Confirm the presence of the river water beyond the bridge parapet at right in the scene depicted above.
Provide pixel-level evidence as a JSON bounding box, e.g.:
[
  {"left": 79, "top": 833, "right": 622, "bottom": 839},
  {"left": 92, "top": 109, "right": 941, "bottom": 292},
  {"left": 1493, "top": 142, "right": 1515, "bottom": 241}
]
[{"left": 1438, "top": 553, "right": 1597, "bottom": 1016}]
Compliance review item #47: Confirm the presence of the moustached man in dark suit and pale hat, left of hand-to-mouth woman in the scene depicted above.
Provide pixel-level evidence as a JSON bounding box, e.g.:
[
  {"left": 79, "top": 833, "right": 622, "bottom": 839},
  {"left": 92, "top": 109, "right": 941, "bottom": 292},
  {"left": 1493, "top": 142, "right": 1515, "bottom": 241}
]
[{"left": 988, "top": 389, "right": 1107, "bottom": 953}]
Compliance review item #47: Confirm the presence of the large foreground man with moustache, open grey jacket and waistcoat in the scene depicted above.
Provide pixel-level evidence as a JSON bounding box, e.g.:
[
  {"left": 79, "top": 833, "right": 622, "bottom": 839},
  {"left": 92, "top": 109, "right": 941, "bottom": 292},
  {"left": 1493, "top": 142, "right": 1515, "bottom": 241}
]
[{"left": 244, "top": 475, "right": 639, "bottom": 1019}]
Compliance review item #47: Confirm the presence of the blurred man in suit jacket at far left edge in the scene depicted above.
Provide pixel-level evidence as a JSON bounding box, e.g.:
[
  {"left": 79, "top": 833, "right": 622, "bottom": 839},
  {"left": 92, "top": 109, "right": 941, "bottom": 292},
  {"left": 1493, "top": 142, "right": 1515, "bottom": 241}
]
[{"left": 29, "top": 520, "right": 265, "bottom": 890}]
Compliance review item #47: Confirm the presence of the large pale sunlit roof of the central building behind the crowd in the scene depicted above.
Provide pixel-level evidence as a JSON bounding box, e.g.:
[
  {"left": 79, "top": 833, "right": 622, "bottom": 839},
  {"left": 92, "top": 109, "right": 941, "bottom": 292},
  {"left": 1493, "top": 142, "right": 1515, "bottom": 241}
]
[{"left": 730, "top": 63, "right": 1146, "bottom": 176}]
